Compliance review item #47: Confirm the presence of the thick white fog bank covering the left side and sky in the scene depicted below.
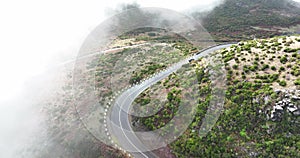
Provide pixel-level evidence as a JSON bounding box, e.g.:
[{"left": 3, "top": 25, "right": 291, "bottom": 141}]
[{"left": 0, "top": 0, "right": 300, "bottom": 158}]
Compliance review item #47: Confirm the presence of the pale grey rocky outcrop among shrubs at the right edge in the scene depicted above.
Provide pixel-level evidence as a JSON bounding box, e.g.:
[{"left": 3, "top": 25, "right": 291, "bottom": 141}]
[{"left": 267, "top": 90, "right": 300, "bottom": 121}]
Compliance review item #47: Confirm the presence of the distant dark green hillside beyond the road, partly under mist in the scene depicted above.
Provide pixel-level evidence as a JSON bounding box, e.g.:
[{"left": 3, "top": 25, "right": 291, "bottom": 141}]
[{"left": 194, "top": 0, "right": 300, "bottom": 41}]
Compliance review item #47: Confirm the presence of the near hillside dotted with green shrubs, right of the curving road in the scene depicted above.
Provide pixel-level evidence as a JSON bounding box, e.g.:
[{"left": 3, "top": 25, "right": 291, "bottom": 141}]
[{"left": 133, "top": 36, "right": 300, "bottom": 157}]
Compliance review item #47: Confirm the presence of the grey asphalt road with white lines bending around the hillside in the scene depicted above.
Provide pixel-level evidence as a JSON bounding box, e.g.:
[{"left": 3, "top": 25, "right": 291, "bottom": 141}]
[{"left": 106, "top": 44, "right": 232, "bottom": 158}]
